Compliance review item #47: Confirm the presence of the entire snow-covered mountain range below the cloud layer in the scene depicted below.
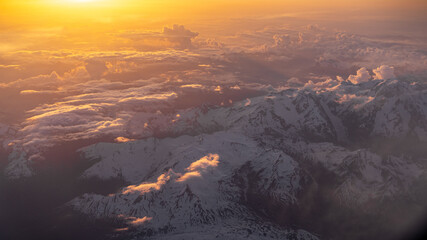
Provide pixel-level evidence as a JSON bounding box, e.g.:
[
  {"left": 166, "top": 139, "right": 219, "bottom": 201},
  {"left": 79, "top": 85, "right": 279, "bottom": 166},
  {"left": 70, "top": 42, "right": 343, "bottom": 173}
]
[{"left": 6, "top": 78, "right": 427, "bottom": 239}]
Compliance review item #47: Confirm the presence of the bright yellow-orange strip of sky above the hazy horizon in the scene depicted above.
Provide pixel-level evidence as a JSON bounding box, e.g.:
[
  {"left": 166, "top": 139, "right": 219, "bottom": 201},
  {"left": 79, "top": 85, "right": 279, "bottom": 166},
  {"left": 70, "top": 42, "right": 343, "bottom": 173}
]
[{"left": 0, "top": 0, "right": 427, "bottom": 27}]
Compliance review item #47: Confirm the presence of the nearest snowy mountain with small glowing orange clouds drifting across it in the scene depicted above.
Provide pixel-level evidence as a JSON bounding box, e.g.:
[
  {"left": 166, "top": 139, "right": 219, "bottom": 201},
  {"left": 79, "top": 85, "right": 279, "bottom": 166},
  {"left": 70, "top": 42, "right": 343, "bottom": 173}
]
[{"left": 69, "top": 132, "right": 314, "bottom": 238}]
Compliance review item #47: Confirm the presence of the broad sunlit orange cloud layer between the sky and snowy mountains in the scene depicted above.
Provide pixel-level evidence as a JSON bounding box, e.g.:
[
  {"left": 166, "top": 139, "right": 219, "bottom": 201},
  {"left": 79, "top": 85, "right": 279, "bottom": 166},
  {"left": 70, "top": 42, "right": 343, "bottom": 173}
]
[{"left": 0, "top": 18, "right": 427, "bottom": 176}]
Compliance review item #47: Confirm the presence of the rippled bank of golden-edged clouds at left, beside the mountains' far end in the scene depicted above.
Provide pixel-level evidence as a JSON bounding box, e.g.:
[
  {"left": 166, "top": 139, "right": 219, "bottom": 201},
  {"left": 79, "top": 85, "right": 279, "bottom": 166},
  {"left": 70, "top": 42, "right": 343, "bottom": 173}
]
[{"left": 6, "top": 77, "right": 183, "bottom": 151}]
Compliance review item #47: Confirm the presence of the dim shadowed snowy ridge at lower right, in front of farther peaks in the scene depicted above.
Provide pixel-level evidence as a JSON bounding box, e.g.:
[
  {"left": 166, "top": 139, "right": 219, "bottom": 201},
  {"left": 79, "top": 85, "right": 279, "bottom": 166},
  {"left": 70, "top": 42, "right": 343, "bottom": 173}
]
[{"left": 287, "top": 142, "right": 425, "bottom": 206}]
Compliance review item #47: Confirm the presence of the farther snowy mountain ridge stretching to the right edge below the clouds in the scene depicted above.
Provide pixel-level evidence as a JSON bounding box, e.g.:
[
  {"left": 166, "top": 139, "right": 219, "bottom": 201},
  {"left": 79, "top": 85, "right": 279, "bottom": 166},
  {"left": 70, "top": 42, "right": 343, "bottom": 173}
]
[{"left": 6, "top": 79, "right": 427, "bottom": 178}]
